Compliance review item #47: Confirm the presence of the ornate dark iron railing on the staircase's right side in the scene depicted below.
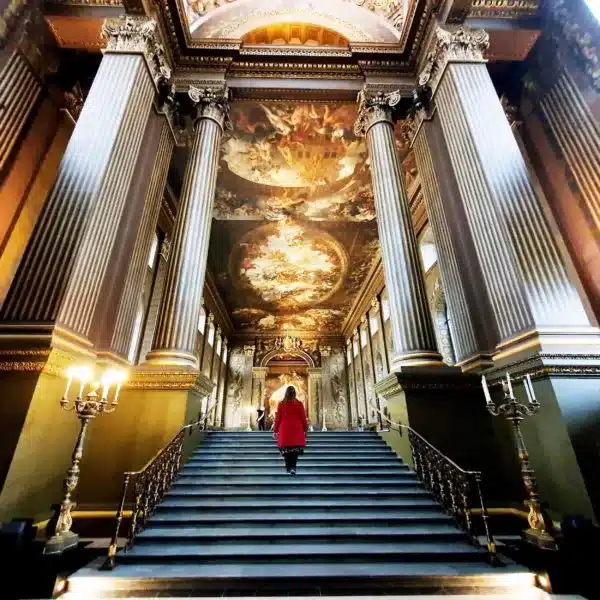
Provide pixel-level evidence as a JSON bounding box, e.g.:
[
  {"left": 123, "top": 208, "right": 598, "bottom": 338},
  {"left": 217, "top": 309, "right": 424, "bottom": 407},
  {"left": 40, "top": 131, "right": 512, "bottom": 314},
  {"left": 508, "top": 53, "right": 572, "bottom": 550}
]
[{"left": 376, "top": 409, "right": 502, "bottom": 565}]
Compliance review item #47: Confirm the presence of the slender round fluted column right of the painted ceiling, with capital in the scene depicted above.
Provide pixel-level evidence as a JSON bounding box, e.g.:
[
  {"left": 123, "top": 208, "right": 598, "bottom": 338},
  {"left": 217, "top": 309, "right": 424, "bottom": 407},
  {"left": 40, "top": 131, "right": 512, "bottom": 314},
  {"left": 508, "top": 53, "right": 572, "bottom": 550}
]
[{"left": 355, "top": 91, "right": 443, "bottom": 370}]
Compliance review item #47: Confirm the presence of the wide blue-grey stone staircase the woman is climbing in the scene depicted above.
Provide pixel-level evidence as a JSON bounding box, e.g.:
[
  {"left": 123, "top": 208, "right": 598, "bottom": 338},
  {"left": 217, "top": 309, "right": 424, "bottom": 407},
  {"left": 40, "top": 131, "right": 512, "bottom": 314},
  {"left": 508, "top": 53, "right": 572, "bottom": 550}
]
[{"left": 69, "top": 432, "right": 537, "bottom": 598}]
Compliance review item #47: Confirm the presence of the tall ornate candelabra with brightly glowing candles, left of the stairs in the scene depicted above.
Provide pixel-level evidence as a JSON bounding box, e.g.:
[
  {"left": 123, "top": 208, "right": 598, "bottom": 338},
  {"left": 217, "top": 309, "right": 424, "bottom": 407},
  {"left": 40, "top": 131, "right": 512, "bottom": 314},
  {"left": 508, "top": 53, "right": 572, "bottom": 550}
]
[{"left": 44, "top": 366, "right": 126, "bottom": 554}]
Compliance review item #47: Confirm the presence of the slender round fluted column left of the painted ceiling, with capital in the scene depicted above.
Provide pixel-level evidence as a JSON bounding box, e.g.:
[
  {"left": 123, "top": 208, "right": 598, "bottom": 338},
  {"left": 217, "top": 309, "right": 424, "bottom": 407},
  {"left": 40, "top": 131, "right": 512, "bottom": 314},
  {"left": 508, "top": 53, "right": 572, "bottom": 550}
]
[{"left": 147, "top": 86, "right": 229, "bottom": 368}]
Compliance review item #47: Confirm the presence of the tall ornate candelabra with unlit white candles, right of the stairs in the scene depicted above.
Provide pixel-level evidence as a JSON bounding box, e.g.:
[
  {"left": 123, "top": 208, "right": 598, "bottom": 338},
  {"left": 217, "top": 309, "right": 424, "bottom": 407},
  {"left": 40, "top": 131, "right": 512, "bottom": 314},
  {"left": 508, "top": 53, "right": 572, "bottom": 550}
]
[{"left": 481, "top": 373, "right": 557, "bottom": 550}]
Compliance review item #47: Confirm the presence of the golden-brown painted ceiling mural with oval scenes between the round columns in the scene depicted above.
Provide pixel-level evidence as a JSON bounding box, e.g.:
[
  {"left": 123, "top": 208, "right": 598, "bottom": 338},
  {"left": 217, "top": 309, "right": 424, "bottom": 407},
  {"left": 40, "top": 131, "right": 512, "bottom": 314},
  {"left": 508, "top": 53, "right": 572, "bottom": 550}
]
[{"left": 209, "top": 101, "right": 379, "bottom": 333}]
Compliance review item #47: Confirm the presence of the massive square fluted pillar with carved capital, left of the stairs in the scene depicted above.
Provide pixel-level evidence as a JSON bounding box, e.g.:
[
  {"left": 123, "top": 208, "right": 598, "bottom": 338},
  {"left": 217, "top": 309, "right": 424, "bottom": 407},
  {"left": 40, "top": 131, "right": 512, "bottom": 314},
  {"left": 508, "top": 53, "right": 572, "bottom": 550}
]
[{"left": 0, "top": 17, "right": 168, "bottom": 346}]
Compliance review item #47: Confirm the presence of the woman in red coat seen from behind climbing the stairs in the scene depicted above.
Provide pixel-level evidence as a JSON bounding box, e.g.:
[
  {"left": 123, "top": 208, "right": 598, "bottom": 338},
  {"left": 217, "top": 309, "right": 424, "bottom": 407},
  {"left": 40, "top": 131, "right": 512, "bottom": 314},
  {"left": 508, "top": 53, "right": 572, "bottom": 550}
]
[{"left": 273, "top": 385, "right": 308, "bottom": 477}]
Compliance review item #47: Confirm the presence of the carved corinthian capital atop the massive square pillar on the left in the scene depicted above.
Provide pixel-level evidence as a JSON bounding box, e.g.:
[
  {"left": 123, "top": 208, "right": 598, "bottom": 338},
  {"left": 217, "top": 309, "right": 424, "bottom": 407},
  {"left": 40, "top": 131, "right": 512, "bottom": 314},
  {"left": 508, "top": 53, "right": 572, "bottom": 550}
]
[{"left": 102, "top": 15, "right": 171, "bottom": 86}]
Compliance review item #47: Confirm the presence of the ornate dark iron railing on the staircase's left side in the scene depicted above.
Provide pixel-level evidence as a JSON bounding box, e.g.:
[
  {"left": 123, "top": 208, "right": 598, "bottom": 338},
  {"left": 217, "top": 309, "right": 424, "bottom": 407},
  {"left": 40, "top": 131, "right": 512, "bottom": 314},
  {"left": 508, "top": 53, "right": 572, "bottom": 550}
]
[{"left": 102, "top": 402, "right": 217, "bottom": 570}]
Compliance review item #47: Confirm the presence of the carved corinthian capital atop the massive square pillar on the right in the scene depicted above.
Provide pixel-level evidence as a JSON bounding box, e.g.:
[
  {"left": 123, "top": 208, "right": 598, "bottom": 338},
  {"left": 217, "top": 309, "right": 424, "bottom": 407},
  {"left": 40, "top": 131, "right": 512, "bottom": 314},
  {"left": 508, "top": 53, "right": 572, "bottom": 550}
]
[{"left": 419, "top": 27, "right": 490, "bottom": 92}]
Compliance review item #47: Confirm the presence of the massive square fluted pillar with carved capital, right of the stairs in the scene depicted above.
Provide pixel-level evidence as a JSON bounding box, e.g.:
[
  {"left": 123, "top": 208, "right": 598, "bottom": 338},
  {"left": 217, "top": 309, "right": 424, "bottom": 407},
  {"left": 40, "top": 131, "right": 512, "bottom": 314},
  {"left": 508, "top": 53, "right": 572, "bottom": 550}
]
[{"left": 417, "top": 28, "right": 595, "bottom": 355}]
